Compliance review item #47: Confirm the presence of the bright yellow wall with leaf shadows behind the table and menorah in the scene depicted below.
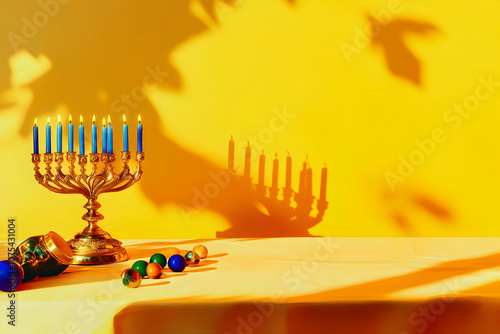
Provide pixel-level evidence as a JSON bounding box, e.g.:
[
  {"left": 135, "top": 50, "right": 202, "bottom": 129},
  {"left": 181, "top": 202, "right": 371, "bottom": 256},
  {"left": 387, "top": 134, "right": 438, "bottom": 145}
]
[{"left": 0, "top": 0, "right": 500, "bottom": 239}]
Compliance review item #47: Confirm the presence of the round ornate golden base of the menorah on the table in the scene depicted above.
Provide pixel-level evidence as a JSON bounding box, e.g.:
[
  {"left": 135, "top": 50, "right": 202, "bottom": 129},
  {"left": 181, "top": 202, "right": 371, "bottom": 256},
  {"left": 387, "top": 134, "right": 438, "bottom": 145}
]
[{"left": 68, "top": 231, "right": 129, "bottom": 265}]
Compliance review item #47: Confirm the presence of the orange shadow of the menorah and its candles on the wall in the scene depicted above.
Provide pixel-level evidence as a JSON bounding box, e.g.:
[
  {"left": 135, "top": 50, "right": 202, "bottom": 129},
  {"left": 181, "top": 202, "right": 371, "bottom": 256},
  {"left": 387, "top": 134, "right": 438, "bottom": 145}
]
[{"left": 216, "top": 138, "right": 328, "bottom": 238}]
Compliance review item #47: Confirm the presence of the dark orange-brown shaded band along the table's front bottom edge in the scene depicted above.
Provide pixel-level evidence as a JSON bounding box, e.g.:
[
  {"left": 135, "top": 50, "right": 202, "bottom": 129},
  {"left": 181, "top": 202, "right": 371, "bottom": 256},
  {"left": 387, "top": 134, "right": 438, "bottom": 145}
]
[{"left": 113, "top": 298, "right": 500, "bottom": 334}]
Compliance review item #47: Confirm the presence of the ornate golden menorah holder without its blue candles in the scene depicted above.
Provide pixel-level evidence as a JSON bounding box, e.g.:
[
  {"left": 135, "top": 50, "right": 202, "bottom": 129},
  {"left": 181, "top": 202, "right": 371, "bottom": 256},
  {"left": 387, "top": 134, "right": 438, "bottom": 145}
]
[{"left": 32, "top": 151, "right": 144, "bottom": 264}]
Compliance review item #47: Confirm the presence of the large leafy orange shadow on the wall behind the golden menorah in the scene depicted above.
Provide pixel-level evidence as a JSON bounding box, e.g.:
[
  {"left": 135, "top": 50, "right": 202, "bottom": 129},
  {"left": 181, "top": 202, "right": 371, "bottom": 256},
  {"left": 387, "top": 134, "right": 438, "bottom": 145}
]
[{"left": 0, "top": 0, "right": 324, "bottom": 237}]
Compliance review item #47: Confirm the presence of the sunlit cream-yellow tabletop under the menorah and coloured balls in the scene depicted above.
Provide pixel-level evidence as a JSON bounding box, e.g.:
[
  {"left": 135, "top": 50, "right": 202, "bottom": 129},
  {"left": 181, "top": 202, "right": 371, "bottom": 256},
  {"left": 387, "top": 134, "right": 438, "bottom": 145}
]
[{"left": 0, "top": 238, "right": 500, "bottom": 334}]
